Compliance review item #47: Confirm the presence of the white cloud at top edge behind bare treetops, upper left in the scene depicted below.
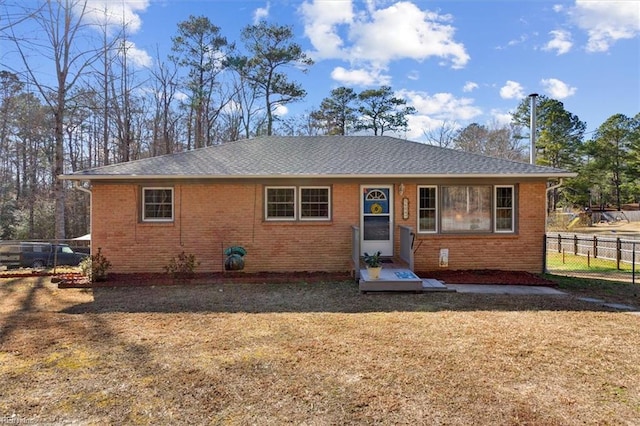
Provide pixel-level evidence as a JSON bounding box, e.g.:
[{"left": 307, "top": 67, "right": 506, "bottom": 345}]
[{"left": 83, "top": 0, "right": 150, "bottom": 34}]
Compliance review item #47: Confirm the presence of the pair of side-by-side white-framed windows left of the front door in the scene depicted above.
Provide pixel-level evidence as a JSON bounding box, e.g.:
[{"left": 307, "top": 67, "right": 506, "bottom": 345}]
[{"left": 265, "top": 186, "right": 331, "bottom": 221}]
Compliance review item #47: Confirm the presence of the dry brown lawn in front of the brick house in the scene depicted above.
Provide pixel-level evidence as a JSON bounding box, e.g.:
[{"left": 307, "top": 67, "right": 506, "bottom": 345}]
[{"left": 0, "top": 278, "right": 640, "bottom": 425}]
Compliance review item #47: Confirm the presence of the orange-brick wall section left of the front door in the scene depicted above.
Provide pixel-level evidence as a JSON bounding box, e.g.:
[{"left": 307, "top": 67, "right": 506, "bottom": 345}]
[{"left": 91, "top": 183, "right": 359, "bottom": 272}]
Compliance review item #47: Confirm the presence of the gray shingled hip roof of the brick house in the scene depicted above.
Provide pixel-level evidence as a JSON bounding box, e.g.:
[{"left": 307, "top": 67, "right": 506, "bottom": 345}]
[{"left": 63, "top": 136, "right": 574, "bottom": 180}]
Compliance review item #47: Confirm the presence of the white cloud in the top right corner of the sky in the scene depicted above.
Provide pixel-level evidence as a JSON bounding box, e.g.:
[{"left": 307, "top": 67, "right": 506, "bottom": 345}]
[{"left": 569, "top": 0, "right": 640, "bottom": 52}]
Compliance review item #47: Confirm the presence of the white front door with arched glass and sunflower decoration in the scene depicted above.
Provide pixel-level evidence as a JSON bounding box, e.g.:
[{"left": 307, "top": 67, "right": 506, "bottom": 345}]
[{"left": 360, "top": 185, "right": 393, "bottom": 256}]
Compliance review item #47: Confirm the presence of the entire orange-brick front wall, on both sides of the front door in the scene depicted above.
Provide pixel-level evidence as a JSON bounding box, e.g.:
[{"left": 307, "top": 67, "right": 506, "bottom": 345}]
[{"left": 91, "top": 182, "right": 545, "bottom": 273}]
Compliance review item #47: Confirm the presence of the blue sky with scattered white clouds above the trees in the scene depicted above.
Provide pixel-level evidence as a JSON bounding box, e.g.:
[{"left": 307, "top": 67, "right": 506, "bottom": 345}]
[{"left": 3, "top": 0, "right": 640, "bottom": 140}]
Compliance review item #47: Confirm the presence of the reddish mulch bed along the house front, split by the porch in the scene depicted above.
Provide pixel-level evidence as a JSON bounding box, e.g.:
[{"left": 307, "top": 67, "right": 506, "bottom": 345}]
[{"left": 52, "top": 270, "right": 555, "bottom": 288}]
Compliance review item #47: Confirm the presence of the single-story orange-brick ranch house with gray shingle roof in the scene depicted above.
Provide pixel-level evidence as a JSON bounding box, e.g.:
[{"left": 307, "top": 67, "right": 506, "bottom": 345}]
[{"left": 61, "top": 136, "right": 574, "bottom": 273}]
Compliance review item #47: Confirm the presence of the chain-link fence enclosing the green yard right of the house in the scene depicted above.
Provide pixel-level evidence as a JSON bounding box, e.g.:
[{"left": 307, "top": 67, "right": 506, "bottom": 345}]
[{"left": 545, "top": 233, "right": 640, "bottom": 284}]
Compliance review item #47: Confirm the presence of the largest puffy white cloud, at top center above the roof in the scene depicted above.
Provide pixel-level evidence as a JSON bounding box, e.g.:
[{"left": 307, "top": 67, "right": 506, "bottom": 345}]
[{"left": 299, "top": 0, "right": 469, "bottom": 68}]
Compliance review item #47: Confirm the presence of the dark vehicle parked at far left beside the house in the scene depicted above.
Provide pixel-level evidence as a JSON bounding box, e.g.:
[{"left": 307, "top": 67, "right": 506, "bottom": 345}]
[{"left": 0, "top": 241, "right": 89, "bottom": 269}]
